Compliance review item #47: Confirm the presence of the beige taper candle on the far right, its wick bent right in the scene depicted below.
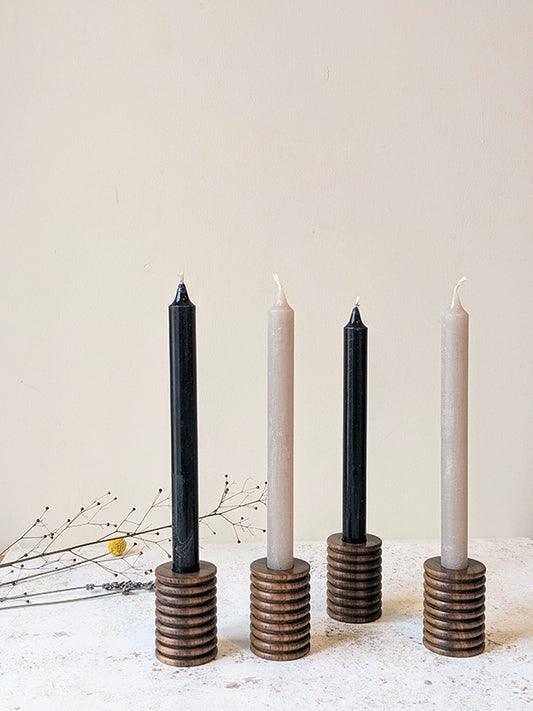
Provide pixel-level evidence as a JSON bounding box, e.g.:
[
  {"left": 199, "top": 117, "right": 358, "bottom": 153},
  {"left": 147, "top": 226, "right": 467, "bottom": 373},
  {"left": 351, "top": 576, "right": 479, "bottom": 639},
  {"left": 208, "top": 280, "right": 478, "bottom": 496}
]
[{"left": 441, "top": 277, "right": 468, "bottom": 570}]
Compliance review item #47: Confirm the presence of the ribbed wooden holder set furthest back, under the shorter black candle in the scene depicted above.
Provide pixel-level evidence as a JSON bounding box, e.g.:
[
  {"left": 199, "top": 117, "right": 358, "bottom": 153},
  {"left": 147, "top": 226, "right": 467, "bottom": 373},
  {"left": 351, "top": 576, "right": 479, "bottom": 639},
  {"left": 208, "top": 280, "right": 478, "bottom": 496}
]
[{"left": 327, "top": 533, "right": 381, "bottom": 623}]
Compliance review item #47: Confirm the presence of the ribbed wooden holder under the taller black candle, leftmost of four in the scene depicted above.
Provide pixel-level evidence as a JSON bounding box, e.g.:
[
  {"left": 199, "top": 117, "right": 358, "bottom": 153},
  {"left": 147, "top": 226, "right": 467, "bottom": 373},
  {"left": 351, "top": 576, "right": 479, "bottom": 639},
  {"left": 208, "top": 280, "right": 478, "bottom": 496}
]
[{"left": 155, "top": 560, "right": 217, "bottom": 667}]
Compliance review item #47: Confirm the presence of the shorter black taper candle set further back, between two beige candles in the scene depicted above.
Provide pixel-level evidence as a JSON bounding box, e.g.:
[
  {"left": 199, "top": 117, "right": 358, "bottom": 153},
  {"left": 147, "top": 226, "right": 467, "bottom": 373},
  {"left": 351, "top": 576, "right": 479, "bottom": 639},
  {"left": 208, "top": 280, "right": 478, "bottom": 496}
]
[{"left": 342, "top": 302, "right": 368, "bottom": 543}]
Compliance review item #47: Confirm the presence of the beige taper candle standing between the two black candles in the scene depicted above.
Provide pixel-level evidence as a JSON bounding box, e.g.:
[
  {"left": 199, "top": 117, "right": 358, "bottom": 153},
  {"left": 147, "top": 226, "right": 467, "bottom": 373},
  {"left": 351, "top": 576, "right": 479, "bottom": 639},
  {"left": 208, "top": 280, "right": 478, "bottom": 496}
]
[{"left": 267, "top": 274, "right": 294, "bottom": 570}]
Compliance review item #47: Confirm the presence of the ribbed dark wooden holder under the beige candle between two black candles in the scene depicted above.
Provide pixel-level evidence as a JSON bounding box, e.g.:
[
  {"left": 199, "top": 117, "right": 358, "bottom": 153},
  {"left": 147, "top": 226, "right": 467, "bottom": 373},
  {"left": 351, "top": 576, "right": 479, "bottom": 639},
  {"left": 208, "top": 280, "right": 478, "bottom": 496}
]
[{"left": 250, "top": 558, "right": 311, "bottom": 662}]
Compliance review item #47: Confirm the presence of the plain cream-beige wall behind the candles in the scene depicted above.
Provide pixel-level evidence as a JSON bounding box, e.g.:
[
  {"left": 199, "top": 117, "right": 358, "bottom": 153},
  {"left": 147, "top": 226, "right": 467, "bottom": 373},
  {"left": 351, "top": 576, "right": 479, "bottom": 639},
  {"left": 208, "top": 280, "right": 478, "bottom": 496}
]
[{"left": 0, "top": 0, "right": 533, "bottom": 543}]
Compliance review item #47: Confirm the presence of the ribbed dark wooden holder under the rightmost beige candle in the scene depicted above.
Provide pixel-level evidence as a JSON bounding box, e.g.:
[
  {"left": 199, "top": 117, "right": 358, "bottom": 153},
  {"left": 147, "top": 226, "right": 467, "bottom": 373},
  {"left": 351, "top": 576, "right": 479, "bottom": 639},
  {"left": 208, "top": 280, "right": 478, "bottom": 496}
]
[{"left": 424, "top": 557, "right": 486, "bottom": 657}]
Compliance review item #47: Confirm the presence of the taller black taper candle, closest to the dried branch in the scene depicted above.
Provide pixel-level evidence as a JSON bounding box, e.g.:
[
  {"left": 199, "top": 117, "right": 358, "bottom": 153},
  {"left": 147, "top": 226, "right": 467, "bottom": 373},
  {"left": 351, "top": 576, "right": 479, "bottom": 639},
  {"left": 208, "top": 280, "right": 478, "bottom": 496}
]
[{"left": 168, "top": 280, "right": 200, "bottom": 573}]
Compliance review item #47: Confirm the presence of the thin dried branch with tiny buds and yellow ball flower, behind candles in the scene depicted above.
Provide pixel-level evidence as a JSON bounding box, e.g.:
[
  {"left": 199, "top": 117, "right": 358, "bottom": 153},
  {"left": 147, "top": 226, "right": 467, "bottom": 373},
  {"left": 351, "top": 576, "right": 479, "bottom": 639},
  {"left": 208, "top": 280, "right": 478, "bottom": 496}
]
[{"left": 0, "top": 475, "right": 266, "bottom": 609}]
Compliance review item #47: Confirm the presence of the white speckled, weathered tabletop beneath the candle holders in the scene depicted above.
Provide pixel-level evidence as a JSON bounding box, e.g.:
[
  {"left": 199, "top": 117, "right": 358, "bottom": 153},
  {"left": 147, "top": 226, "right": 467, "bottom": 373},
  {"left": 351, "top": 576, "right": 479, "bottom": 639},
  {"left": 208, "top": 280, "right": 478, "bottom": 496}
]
[{"left": 0, "top": 538, "right": 533, "bottom": 711}]
